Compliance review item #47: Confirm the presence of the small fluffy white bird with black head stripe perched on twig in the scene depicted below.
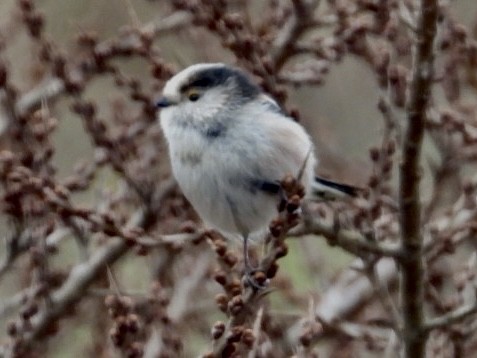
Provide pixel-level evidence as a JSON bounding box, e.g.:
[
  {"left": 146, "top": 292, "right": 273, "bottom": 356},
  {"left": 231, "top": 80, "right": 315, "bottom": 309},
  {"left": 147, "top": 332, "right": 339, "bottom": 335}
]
[{"left": 156, "top": 63, "right": 357, "bottom": 286}]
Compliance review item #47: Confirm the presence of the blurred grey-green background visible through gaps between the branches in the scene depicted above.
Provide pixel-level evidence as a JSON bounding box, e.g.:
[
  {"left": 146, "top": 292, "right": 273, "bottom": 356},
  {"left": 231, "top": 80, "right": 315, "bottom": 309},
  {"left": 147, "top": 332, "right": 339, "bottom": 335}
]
[{"left": 0, "top": 0, "right": 477, "bottom": 357}]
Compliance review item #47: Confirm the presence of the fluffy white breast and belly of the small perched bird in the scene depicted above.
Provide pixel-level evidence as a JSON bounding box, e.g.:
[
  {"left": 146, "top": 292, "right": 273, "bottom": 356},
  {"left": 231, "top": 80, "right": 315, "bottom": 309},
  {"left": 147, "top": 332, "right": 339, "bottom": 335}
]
[{"left": 161, "top": 102, "right": 315, "bottom": 239}]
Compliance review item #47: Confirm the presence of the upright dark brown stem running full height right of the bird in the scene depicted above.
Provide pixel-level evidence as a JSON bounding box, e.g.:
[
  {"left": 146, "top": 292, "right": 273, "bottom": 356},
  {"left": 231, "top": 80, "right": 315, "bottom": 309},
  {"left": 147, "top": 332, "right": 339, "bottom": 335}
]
[{"left": 399, "top": 0, "right": 439, "bottom": 358}]
